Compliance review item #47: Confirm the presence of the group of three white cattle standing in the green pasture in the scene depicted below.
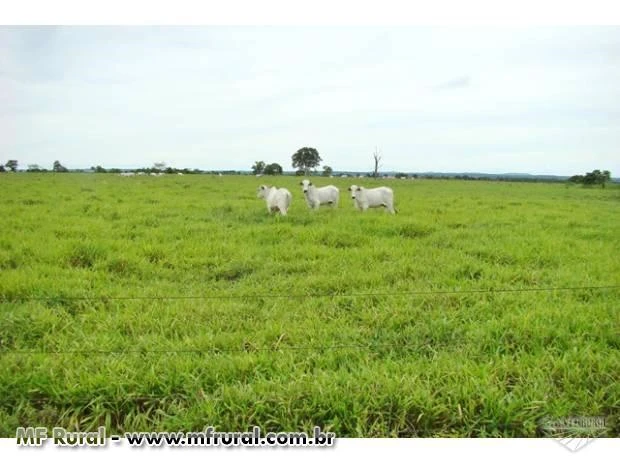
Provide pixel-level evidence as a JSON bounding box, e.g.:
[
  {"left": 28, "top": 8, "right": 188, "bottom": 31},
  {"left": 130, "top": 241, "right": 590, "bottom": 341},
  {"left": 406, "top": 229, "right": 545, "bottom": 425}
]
[{"left": 256, "top": 179, "right": 396, "bottom": 216}]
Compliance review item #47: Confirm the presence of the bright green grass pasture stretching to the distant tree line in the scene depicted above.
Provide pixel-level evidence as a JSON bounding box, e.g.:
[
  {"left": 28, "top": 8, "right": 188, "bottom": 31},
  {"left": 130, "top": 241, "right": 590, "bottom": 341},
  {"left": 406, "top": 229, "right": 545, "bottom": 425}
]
[{"left": 0, "top": 173, "right": 620, "bottom": 437}]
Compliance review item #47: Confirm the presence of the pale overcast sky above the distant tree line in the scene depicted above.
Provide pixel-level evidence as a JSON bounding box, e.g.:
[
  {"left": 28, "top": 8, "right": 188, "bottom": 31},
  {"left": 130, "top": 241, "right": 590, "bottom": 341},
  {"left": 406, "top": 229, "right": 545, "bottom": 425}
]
[{"left": 0, "top": 26, "right": 620, "bottom": 177}]
